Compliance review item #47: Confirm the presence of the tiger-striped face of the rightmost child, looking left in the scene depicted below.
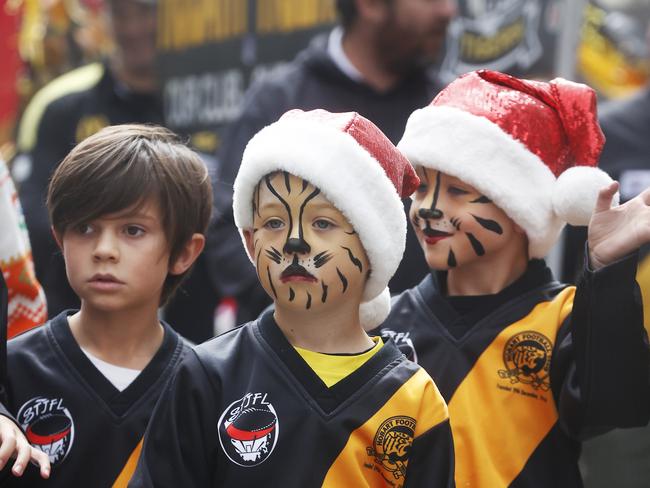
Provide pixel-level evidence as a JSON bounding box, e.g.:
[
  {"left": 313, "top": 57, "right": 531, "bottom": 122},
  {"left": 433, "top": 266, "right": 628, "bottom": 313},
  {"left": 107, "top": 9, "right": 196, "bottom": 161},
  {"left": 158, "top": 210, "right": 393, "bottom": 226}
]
[{"left": 409, "top": 166, "right": 525, "bottom": 270}]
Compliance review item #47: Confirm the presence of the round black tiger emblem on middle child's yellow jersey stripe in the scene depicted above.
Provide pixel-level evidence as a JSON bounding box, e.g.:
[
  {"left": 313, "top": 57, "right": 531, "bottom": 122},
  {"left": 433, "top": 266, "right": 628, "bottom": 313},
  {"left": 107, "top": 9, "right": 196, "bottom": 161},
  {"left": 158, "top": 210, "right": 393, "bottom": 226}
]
[{"left": 366, "top": 415, "right": 415, "bottom": 481}]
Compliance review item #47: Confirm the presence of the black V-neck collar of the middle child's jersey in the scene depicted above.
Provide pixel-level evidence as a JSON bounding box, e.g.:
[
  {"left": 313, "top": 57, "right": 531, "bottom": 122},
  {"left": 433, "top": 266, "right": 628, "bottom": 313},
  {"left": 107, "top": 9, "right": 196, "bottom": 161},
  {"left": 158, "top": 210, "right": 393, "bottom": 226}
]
[{"left": 257, "top": 311, "right": 402, "bottom": 414}]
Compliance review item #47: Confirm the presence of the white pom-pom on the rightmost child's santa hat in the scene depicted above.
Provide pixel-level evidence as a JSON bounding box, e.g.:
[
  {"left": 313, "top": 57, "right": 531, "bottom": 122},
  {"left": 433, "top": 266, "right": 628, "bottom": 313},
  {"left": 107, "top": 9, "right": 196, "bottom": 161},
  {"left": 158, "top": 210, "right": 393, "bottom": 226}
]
[{"left": 552, "top": 166, "right": 619, "bottom": 225}]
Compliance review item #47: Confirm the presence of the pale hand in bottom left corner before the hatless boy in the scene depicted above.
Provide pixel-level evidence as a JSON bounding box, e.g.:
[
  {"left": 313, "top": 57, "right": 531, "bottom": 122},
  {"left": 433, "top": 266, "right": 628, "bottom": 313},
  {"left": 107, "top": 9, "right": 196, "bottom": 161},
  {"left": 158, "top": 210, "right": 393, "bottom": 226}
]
[{"left": 0, "top": 415, "right": 50, "bottom": 479}]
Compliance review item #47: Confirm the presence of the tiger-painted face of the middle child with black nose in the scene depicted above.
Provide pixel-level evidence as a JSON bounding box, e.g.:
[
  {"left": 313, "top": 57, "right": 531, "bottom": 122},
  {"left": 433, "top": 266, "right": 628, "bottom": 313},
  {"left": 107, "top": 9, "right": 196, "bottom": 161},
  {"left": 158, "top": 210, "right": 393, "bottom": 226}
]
[{"left": 245, "top": 172, "right": 370, "bottom": 311}]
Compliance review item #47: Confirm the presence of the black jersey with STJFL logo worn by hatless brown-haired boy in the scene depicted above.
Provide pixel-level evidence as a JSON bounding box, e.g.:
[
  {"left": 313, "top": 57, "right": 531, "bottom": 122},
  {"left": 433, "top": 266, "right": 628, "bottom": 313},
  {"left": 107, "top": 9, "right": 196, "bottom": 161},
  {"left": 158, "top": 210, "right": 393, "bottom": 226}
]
[{"left": 2, "top": 312, "right": 190, "bottom": 488}]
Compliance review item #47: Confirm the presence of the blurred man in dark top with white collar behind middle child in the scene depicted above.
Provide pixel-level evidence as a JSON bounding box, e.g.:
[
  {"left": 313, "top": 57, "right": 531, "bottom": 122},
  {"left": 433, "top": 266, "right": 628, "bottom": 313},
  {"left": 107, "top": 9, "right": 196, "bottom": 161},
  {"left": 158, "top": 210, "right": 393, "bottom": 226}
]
[{"left": 205, "top": 0, "right": 456, "bottom": 323}]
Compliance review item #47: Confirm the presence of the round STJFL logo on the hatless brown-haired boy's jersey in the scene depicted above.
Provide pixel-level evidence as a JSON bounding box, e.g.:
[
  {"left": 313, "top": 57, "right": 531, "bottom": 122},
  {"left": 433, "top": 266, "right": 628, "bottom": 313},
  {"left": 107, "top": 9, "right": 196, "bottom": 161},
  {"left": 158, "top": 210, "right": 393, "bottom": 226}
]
[{"left": 16, "top": 397, "right": 74, "bottom": 466}]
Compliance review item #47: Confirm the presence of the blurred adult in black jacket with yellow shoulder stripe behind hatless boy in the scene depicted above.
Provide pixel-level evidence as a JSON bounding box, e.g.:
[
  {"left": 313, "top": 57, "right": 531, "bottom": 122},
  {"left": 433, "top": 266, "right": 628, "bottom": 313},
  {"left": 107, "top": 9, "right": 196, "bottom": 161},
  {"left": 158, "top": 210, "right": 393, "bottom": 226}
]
[{"left": 12, "top": 0, "right": 163, "bottom": 316}]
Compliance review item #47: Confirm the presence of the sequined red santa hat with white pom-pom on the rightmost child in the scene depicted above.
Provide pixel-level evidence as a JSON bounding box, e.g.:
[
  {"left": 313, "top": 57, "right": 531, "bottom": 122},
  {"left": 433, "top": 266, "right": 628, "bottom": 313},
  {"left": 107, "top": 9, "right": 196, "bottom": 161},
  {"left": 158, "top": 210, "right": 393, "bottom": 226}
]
[{"left": 398, "top": 70, "right": 618, "bottom": 258}]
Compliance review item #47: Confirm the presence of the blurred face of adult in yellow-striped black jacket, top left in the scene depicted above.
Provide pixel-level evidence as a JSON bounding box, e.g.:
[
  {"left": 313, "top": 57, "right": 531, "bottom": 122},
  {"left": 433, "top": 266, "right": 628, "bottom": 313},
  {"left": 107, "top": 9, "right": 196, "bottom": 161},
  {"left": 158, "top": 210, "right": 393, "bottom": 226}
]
[{"left": 107, "top": 0, "right": 158, "bottom": 75}]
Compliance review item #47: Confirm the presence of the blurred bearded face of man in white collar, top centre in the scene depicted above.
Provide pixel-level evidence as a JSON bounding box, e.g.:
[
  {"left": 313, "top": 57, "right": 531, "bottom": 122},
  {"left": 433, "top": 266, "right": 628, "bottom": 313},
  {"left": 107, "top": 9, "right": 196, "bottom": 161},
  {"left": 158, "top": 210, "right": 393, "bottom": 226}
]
[{"left": 377, "top": 0, "right": 456, "bottom": 74}]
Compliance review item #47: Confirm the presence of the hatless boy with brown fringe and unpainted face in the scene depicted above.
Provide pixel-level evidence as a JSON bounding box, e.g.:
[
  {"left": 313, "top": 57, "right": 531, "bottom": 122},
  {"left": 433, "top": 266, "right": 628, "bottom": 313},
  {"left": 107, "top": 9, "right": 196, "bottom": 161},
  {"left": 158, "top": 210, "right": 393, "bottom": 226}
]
[{"left": 3, "top": 125, "right": 212, "bottom": 487}]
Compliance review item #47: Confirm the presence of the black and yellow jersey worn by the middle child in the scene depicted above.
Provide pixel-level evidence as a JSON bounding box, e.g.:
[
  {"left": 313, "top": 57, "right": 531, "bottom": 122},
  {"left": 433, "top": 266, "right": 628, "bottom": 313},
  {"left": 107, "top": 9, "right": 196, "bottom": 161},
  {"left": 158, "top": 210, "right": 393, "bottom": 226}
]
[{"left": 129, "top": 312, "right": 453, "bottom": 488}]
